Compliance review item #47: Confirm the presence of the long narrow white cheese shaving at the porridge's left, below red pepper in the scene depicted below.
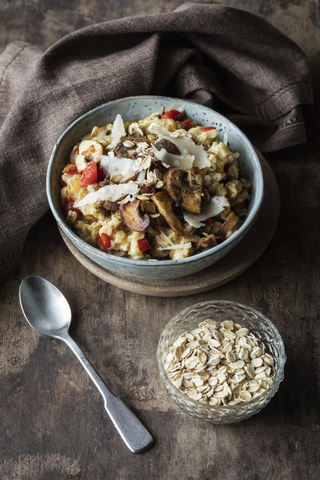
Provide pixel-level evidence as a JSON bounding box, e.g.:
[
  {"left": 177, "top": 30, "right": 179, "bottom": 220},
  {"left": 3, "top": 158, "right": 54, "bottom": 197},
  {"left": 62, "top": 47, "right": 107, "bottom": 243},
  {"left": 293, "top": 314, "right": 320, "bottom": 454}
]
[{"left": 74, "top": 182, "right": 139, "bottom": 208}]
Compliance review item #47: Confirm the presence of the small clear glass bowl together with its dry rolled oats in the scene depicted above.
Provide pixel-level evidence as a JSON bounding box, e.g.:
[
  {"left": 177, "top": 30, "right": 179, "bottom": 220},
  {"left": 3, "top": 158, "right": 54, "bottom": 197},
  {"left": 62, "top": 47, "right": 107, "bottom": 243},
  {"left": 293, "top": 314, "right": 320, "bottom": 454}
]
[{"left": 157, "top": 300, "right": 287, "bottom": 424}]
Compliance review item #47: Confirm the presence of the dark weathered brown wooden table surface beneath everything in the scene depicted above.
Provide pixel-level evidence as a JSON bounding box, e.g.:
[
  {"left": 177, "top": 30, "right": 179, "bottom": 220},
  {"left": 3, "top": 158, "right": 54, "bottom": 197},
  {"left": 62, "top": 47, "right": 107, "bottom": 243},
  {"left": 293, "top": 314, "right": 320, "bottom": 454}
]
[{"left": 0, "top": 0, "right": 320, "bottom": 480}]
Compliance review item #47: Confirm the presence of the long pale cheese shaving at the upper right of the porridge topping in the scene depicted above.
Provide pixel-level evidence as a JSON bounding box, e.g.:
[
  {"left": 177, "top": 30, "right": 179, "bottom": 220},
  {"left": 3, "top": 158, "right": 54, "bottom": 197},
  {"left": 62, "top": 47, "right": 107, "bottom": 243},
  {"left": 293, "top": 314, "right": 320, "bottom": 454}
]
[{"left": 150, "top": 123, "right": 211, "bottom": 168}]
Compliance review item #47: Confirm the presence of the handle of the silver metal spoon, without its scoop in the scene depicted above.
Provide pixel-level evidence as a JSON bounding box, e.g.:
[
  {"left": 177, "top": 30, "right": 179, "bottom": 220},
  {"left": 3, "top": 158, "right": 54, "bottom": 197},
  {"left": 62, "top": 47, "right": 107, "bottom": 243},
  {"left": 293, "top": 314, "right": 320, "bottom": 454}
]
[{"left": 61, "top": 334, "right": 153, "bottom": 453}]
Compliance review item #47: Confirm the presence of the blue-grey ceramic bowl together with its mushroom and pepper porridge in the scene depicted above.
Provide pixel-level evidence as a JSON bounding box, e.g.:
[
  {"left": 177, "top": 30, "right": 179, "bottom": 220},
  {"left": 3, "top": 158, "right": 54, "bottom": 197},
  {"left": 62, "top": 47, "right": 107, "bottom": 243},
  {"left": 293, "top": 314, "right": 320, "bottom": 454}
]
[{"left": 47, "top": 96, "right": 264, "bottom": 279}]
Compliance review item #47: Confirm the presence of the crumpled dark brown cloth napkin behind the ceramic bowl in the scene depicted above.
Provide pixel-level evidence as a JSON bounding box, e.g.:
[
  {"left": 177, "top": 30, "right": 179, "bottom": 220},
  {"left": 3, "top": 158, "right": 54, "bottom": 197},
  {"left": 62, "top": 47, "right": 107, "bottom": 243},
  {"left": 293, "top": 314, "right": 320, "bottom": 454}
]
[{"left": 0, "top": 3, "right": 312, "bottom": 280}]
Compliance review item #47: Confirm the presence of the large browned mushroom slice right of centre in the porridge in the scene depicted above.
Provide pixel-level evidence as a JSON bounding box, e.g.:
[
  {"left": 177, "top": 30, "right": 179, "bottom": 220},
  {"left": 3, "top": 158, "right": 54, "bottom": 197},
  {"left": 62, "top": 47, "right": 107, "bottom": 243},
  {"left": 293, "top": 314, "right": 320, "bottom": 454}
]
[{"left": 166, "top": 168, "right": 203, "bottom": 213}]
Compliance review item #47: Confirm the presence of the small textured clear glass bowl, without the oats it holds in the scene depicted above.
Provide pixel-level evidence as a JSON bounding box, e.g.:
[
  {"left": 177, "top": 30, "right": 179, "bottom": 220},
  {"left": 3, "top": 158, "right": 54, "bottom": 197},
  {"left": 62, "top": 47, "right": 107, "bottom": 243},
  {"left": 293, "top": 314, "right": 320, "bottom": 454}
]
[{"left": 157, "top": 300, "right": 286, "bottom": 424}]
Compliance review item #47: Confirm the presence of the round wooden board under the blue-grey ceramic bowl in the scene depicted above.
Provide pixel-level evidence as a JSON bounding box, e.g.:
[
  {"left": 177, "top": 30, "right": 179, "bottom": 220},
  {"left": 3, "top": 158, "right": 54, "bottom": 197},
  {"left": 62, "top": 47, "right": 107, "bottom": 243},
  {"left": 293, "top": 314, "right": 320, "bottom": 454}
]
[{"left": 60, "top": 153, "right": 280, "bottom": 297}]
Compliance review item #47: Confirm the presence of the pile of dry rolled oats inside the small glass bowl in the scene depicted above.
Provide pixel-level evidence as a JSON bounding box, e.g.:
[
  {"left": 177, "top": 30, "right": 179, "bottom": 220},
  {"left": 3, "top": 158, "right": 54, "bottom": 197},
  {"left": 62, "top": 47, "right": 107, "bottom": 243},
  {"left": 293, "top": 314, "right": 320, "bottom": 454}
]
[{"left": 165, "top": 319, "right": 274, "bottom": 405}]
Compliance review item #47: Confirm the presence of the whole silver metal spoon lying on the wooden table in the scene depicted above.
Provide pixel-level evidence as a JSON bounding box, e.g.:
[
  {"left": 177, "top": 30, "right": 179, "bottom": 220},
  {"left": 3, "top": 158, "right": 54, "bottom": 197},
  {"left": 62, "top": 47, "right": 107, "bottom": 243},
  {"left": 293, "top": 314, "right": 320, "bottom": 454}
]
[{"left": 19, "top": 276, "right": 153, "bottom": 453}]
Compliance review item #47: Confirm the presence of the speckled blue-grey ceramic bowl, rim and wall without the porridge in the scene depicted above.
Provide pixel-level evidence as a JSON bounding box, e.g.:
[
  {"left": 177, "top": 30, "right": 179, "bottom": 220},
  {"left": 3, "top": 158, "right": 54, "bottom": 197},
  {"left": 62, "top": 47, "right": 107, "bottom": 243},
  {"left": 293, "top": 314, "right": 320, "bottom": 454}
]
[{"left": 46, "top": 96, "right": 264, "bottom": 280}]
